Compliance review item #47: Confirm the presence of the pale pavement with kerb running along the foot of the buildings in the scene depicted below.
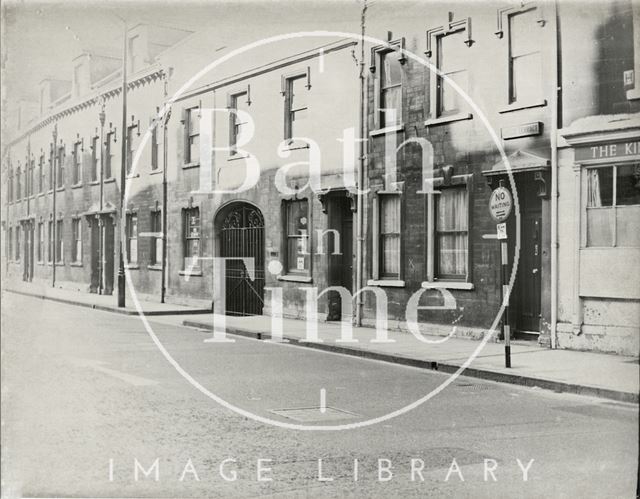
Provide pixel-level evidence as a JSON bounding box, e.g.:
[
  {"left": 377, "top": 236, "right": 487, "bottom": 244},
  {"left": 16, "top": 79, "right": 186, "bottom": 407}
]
[{"left": 9, "top": 283, "right": 640, "bottom": 404}]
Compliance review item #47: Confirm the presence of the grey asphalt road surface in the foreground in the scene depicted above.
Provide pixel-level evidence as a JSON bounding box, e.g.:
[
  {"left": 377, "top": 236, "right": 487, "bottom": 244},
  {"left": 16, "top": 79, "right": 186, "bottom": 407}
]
[{"left": 2, "top": 293, "right": 638, "bottom": 498}]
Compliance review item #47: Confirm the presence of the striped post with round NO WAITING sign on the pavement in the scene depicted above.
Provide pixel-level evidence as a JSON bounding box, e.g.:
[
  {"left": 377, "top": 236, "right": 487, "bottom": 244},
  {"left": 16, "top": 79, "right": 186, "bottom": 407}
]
[{"left": 489, "top": 180, "right": 513, "bottom": 367}]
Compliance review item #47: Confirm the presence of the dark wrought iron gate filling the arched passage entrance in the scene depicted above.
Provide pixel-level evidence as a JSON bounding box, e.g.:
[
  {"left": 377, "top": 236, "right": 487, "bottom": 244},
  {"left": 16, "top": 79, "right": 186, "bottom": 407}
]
[{"left": 220, "top": 203, "right": 264, "bottom": 315}]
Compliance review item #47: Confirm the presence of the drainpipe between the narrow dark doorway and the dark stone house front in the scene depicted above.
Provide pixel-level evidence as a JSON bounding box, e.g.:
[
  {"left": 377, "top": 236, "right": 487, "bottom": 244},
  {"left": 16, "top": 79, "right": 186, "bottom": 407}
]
[{"left": 355, "top": 0, "right": 367, "bottom": 326}]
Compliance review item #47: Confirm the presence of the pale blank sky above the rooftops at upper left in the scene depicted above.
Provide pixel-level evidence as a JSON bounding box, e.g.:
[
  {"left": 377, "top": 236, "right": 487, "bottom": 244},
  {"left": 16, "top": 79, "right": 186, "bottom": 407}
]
[{"left": 2, "top": 0, "right": 360, "bottom": 104}]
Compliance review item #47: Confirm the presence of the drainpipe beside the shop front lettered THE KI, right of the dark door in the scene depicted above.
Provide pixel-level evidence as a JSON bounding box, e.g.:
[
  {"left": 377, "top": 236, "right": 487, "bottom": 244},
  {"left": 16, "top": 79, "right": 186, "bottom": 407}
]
[{"left": 550, "top": 1, "right": 562, "bottom": 349}]
